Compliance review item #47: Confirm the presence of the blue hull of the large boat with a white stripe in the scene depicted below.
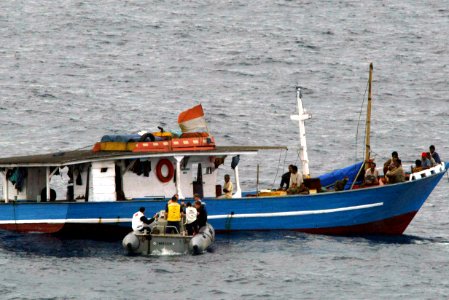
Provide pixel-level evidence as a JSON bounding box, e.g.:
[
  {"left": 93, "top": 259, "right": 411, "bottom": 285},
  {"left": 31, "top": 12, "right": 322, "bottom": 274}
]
[{"left": 0, "top": 172, "right": 445, "bottom": 236}]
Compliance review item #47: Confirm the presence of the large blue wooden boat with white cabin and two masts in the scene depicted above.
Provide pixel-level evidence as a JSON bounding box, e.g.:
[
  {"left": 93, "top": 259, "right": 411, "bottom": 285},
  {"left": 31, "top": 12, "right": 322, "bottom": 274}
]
[{"left": 0, "top": 66, "right": 448, "bottom": 237}]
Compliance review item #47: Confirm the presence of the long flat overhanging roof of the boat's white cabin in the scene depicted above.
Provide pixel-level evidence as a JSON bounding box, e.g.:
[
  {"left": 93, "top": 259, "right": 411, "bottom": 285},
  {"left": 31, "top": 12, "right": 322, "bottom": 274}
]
[{"left": 0, "top": 146, "right": 287, "bottom": 168}]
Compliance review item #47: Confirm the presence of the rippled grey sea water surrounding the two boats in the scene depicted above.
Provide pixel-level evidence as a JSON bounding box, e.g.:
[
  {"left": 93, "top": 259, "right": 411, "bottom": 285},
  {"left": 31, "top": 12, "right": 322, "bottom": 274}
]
[{"left": 0, "top": 0, "right": 449, "bottom": 299}]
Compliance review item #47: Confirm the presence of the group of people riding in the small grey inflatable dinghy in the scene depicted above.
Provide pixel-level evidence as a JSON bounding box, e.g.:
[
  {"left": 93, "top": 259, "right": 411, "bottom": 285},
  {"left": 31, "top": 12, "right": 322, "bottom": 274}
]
[{"left": 131, "top": 194, "right": 207, "bottom": 235}]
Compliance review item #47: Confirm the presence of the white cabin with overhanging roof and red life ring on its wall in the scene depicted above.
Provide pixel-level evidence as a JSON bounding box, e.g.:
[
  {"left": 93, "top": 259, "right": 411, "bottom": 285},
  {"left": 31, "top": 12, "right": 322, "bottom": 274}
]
[{"left": 0, "top": 147, "right": 282, "bottom": 202}]
